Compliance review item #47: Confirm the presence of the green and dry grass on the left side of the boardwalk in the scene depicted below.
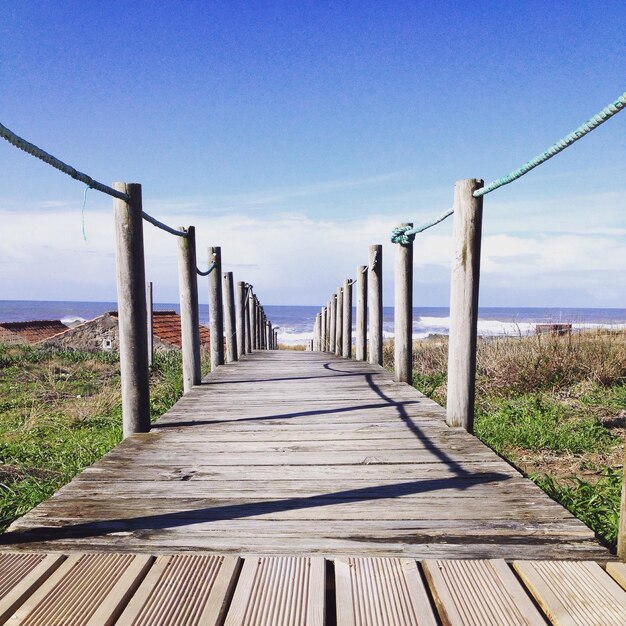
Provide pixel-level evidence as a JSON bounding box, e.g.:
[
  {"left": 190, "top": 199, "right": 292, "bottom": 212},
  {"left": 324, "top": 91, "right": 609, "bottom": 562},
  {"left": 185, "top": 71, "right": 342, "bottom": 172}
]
[{"left": 0, "top": 345, "right": 206, "bottom": 530}]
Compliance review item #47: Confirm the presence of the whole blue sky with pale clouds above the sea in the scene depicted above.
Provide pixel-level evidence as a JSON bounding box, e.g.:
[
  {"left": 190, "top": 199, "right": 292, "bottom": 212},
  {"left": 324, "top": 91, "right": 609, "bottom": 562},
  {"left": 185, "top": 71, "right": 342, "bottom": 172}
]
[{"left": 0, "top": 1, "right": 626, "bottom": 308}]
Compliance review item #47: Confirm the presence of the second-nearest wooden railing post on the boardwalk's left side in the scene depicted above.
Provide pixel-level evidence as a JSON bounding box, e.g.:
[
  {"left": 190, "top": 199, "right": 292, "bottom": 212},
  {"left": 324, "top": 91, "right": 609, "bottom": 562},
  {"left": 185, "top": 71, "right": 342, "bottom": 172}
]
[{"left": 178, "top": 226, "right": 202, "bottom": 393}]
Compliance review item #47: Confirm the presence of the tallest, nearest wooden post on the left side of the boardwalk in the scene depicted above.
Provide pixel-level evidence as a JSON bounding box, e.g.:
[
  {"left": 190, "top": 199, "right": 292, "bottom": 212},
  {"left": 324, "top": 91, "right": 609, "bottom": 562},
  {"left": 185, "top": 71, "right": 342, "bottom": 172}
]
[{"left": 113, "top": 183, "right": 150, "bottom": 437}]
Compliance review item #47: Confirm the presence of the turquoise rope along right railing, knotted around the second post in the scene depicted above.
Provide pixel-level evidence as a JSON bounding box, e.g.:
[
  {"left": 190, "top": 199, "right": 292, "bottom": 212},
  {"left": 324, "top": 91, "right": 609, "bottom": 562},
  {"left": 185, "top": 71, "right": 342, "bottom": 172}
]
[{"left": 391, "top": 93, "right": 626, "bottom": 245}]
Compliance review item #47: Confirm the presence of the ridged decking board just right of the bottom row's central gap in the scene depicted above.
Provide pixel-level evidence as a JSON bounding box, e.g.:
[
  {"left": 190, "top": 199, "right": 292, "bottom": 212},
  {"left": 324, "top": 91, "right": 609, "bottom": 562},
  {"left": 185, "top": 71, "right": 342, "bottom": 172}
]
[{"left": 334, "top": 558, "right": 437, "bottom": 626}]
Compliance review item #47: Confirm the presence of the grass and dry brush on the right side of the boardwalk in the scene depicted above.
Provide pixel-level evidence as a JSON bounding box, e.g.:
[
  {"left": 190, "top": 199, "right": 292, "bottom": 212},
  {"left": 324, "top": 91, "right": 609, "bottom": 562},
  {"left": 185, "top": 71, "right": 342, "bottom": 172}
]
[{"left": 385, "top": 330, "right": 626, "bottom": 546}]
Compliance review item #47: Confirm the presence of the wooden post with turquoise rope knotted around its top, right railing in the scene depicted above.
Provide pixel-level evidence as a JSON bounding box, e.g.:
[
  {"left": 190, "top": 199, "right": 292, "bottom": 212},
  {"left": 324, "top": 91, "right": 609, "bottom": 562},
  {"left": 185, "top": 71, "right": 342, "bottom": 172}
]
[{"left": 393, "top": 224, "right": 413, "bottom": 384}]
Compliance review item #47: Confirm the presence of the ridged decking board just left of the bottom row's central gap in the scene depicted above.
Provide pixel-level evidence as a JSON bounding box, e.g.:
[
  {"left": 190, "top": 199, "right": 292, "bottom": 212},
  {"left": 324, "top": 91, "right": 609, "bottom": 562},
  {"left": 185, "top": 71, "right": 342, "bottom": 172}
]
[{"left": 225, "top": 557, "right": 326, "bottom": 626}]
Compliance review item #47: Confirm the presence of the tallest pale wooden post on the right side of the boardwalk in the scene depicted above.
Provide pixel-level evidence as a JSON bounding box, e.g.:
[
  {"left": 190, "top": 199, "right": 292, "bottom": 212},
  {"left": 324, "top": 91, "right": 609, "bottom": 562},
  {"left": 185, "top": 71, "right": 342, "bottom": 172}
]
[{"left": 446, "top": 178, "right": 483, "bottom": 433}]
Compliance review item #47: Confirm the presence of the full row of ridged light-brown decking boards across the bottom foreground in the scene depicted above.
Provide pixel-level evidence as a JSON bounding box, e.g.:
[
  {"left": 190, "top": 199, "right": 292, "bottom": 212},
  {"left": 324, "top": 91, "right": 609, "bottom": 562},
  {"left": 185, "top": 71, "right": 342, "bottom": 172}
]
[{"left": 0, "top": 552, "right": 626, "bottom": 626}]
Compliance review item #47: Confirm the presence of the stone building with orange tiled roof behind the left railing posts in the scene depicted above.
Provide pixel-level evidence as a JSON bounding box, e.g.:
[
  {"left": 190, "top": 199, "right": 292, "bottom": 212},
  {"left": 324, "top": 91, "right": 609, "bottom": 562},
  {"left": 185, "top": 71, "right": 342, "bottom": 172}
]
[{"left": 43, "top": 311, "right": 209, "bottom": 352}]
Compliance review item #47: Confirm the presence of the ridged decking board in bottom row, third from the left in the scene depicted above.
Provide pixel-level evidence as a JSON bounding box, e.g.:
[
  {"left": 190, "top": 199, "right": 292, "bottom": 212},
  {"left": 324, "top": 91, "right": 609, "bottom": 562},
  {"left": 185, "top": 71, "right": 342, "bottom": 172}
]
[{"left": 116, "top": 555, "right": 240, "bottom": 626}]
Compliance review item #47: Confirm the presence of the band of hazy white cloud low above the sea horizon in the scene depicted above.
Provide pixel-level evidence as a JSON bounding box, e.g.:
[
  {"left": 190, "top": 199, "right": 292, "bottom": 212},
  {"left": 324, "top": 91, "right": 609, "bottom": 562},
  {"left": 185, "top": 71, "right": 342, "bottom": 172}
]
[{"left": 0, "top": 184, "right": 626, "bottom": 307}]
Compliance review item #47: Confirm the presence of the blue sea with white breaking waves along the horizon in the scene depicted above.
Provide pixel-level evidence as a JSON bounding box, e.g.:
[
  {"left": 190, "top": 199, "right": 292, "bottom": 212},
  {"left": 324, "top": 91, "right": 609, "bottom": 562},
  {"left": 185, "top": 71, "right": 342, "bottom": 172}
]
[{"left": 0, "top": 300, "right": 626, "bottom": 345}]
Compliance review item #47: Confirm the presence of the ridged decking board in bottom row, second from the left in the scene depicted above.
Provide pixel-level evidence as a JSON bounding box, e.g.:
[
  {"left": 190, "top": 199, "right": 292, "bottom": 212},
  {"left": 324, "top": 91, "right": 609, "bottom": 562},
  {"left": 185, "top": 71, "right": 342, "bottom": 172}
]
[{"left": 7, "top": 553, "right": 154, "bottom": 626}]
